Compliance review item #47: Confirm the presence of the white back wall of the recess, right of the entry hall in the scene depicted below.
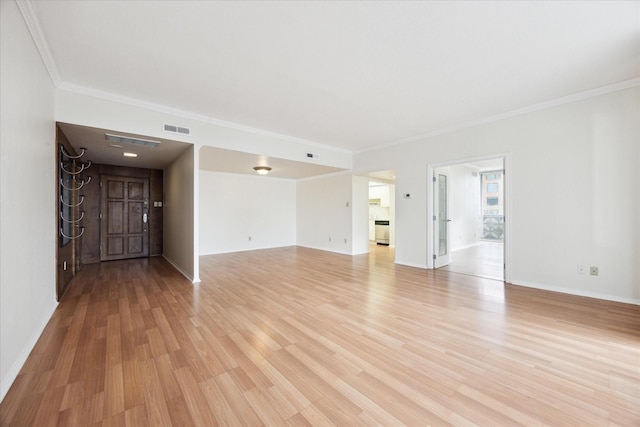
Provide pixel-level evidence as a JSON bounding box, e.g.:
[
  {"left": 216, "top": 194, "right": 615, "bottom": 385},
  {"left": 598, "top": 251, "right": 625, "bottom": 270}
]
[{"left": 199, "top": 170, "right": 296, "bottom": 255}]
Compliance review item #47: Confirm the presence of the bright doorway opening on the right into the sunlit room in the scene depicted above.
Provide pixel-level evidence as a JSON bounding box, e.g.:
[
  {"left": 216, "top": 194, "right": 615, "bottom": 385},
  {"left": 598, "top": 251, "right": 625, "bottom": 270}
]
[{"left": 430, "top": 157, "right": 506, "bottom": 281}]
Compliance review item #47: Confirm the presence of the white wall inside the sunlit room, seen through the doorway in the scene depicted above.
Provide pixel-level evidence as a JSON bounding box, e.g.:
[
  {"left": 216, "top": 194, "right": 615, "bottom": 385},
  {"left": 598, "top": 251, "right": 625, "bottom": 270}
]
[{"left": 449, "top": 165, "right": 482, "bottom": 251}]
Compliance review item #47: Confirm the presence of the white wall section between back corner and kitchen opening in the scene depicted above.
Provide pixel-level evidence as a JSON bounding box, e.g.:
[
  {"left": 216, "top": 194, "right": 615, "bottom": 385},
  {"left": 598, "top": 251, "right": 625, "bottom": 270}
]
[{"left": 296, "top": 173, "right": 352, "bottom": 254}]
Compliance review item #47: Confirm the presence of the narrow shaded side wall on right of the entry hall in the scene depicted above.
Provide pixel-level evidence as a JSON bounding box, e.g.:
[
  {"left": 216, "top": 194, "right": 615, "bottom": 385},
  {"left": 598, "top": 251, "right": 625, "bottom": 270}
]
[{"left": 163, "top": 146, "right": 199, "bottom": 282}]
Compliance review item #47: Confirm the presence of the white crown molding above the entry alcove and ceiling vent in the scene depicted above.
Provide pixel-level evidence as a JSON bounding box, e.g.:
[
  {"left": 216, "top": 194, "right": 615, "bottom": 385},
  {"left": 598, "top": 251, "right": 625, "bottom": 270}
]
[{"left": 58, "top": 82, "right": 352, "bottom": 154}]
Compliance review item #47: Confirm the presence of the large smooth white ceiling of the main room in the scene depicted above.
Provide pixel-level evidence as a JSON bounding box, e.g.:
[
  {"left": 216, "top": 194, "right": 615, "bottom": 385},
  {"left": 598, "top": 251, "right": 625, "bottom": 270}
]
[{"left": 33, "top": 0, "right": 640, "bottom": 172}]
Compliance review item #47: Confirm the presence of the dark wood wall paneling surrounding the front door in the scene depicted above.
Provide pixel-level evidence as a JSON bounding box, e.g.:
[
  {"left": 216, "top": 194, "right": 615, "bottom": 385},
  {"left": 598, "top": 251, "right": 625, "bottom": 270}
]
[{"left": 80, "top": 164, "right": 164, "bottom": 264}]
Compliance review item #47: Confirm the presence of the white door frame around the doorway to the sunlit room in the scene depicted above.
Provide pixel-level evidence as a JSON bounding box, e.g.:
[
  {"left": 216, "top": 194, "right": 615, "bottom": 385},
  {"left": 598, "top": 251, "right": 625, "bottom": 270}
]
[{"left": 426, "top": 152, "right": 512, "bottom": 283}]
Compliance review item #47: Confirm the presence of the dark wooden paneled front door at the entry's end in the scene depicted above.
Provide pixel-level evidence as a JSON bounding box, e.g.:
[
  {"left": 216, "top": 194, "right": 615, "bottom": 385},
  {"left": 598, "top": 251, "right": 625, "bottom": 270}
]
[{"left": 100, "top": 175, "right": 149, "bottom": 261}]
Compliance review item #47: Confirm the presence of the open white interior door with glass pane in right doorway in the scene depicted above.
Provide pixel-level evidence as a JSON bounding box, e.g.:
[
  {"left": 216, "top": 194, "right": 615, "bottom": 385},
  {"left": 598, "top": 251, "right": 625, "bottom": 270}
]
[{"left": 433, "top": 168, "right": 451, "bottom": 268}]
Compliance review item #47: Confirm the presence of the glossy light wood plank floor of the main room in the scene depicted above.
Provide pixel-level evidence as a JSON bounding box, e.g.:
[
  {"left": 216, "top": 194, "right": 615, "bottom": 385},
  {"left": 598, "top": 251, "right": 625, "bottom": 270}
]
[{"left": 0, "top": 246, "right": 640, "bottom": 426}]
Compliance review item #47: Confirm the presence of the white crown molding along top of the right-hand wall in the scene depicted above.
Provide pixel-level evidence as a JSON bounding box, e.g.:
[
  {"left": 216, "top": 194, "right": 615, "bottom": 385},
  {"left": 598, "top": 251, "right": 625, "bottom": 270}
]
[{"left": 354, "top": 77, "right": 640, "bottom": 154}]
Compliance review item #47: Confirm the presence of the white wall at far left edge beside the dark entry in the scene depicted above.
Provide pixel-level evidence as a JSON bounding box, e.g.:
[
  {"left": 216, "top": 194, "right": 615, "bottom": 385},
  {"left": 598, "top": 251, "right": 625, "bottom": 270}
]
[{"left": 0, "top": 1, "right": 56, "bottom": 400}]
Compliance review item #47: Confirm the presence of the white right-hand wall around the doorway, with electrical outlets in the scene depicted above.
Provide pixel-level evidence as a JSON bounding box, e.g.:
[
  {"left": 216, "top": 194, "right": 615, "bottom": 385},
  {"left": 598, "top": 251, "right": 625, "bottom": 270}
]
[{"left": 354, "top": 86, "right": 640, "bottom": 303}]
